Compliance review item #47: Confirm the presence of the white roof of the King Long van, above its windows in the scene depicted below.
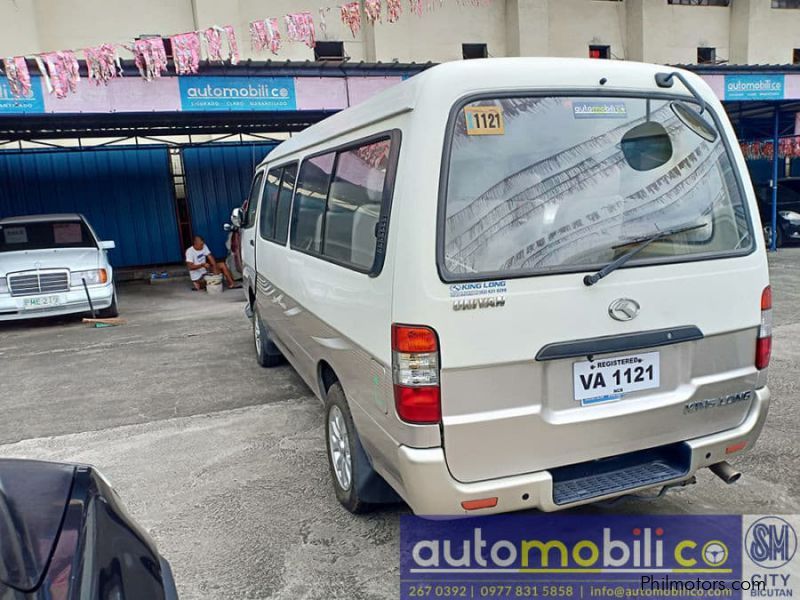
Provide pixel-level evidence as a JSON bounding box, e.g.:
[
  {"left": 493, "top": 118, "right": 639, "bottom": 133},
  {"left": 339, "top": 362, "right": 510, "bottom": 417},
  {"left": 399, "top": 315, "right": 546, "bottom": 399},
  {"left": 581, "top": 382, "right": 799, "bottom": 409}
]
[{"left": 262, "top": 57, "right": 700, "bottom": 164}]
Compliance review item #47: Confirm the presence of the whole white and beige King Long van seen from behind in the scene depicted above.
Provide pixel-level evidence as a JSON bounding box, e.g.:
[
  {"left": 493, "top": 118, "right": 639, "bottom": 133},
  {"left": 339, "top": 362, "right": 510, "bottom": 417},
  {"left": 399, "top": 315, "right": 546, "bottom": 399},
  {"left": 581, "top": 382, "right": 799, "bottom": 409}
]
[{"left": 234, "top": 58, "right": 771, "bottom": 515}]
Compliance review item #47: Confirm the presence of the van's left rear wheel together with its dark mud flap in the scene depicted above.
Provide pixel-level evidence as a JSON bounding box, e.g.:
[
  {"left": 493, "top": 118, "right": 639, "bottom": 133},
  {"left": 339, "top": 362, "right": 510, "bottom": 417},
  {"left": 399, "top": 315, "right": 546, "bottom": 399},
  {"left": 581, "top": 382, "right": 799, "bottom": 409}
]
[{"left": 325, "top": 381, "right": 402, "bottom": 514}]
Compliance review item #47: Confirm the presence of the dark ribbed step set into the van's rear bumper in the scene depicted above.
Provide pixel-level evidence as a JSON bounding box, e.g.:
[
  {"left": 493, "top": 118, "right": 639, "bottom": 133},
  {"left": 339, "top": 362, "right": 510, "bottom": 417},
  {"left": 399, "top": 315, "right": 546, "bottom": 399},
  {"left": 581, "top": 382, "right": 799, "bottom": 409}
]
[{"left": 550, "top": 444, "right": 691, "bottom": 506}]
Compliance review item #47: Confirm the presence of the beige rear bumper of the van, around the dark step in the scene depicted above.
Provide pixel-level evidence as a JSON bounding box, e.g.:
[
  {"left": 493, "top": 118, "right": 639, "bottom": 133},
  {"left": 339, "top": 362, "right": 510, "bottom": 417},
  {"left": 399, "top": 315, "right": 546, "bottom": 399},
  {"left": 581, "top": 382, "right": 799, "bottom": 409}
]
[{"left": 397, "top": 387, "right": 770, "bottom": 516}]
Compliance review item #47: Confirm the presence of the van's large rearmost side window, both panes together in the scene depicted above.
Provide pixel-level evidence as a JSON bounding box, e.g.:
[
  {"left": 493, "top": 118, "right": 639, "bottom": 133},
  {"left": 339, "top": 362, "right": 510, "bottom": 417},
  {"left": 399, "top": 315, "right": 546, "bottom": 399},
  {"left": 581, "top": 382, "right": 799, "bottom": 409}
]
[{"left": 291, "top": 138, "right": 392, "bottom": 271}]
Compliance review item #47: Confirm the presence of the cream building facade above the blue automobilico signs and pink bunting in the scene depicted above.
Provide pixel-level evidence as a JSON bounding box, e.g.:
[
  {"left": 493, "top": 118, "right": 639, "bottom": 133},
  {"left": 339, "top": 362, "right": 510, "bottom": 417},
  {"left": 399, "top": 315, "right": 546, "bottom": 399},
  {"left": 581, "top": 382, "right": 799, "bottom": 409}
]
[{"left": 0, "top": 0, "right": 800, "bottom": 64}]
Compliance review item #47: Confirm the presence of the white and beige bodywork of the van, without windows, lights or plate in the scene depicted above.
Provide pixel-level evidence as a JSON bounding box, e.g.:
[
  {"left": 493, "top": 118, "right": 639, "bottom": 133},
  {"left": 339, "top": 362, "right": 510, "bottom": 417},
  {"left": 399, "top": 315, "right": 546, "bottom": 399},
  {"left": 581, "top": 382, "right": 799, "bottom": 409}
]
[{"left": 248, "top": 58, "right": 769, "bottom": 514}]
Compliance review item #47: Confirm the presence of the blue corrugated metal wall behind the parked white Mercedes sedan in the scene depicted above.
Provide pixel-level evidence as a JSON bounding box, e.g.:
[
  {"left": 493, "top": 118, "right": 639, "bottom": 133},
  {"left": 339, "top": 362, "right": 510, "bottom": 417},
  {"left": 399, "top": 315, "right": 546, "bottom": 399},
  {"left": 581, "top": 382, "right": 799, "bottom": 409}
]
[{"left": 0, "top": 147, "right": 182, "bottom": 267}]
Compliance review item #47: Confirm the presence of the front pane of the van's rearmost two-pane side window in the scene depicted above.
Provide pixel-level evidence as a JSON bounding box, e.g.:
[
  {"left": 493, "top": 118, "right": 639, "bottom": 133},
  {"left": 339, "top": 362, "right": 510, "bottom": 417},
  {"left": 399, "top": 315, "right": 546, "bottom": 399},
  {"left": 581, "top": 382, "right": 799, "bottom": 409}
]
[{"left": 292, "top": 152, "right": 335, "bottom": 254}]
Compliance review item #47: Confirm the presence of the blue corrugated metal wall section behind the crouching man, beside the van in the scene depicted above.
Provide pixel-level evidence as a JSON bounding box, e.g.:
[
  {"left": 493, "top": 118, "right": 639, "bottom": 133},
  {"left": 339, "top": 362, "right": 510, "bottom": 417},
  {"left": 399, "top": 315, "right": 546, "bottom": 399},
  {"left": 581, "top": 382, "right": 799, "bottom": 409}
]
[{"left": 183, "top": 143, "right": 276, "bottom": 257}]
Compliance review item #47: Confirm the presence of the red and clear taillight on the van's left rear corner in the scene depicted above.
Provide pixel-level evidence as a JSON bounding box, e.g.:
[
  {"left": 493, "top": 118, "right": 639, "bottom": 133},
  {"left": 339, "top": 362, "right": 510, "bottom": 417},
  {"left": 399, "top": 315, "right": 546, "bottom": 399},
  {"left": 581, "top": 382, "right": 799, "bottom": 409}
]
[{"left": 392, "top": 325, "right": 442, "bottom": 424}]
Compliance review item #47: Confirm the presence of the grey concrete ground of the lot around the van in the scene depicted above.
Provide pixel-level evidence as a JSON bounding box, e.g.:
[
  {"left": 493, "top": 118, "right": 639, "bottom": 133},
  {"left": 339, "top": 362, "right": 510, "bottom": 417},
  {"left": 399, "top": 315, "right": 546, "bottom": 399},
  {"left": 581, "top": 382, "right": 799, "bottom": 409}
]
[{"left": 0, "top": 254, "right": 800, "bottom": 599}]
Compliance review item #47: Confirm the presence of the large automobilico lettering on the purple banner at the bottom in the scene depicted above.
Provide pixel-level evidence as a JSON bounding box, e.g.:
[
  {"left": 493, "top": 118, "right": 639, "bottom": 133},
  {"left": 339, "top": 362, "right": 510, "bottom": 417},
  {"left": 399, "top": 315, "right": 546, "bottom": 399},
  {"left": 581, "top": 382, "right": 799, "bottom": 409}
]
[{"left": 409, "top": 527, "right": 732, "bottom": 573}]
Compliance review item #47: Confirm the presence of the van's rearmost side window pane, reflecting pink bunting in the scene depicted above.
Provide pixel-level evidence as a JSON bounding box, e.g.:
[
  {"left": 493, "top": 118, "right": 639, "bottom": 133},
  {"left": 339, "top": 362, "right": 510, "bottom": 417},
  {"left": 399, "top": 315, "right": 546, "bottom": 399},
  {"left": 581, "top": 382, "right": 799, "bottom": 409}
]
[{"left": 322, "top": 139, "right": 391, "bottom": 269}]
